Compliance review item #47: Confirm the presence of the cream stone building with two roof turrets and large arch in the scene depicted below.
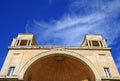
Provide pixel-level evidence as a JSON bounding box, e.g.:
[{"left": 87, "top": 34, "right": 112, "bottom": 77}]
[{"left": 0, "top": 34, "right": 120, "bottom": 81}]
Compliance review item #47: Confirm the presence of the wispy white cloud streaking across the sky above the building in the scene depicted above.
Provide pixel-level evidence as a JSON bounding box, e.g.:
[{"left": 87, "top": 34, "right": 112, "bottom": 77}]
[{"left": 26, "top": 0, "right": 120, "bottom": 71}]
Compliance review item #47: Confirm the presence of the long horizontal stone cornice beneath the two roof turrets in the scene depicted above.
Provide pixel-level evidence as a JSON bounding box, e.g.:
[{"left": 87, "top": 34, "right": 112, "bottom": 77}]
[{"left": 8, "top": 46, "right": 111, "bottom": 50}]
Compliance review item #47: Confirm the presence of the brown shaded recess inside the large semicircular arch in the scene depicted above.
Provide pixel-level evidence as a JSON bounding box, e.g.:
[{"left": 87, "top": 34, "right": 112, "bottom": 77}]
[{"left": 24, "top": 54, "right": 95, "bottom": 81}]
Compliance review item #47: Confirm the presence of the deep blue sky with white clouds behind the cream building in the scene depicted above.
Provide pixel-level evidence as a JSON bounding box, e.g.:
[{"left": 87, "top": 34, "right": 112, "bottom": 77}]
[{"left": 0, "top": 0, "right": 120, "bottom": 72}]
